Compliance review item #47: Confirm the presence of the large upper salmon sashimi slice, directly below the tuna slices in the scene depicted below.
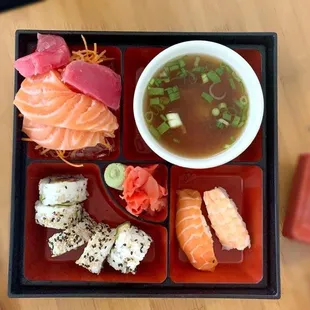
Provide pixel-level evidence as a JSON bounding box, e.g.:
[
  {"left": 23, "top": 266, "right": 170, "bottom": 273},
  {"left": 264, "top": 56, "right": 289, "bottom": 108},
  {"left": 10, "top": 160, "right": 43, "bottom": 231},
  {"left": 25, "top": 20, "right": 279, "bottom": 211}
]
[{"left": 14, "top": 71, "right": 118, "bottom": 132}]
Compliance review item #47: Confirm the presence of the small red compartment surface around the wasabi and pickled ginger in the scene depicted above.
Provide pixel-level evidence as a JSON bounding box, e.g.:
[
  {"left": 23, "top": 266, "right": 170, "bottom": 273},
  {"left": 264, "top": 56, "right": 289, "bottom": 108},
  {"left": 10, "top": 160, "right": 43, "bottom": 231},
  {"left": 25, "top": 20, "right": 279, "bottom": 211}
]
[{"left": 103, "top": 164, "right": 168, "bottom": 222}]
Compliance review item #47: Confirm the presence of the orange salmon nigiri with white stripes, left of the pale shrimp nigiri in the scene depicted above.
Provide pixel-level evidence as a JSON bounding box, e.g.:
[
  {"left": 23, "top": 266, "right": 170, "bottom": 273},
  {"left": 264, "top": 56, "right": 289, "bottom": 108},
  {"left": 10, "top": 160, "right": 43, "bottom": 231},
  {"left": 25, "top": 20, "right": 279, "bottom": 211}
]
[{"left": 176, "top": 189, "right": 217, "bottom": 271}]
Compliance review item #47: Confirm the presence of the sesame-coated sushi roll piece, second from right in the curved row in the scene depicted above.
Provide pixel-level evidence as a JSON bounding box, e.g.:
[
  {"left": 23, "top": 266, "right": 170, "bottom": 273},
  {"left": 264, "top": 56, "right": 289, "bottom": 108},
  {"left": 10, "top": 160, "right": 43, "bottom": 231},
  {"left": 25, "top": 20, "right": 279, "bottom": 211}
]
[{"left": 75, "top": 223, "right": 116, "bottom": 274}]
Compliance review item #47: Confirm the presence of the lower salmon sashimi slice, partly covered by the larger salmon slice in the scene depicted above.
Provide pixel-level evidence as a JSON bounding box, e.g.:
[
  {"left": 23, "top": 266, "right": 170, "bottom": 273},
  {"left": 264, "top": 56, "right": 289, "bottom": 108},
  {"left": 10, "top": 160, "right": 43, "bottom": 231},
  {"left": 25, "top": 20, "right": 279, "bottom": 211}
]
[{"left": 22, "top": 118, "right": 113, "bottom": 151}]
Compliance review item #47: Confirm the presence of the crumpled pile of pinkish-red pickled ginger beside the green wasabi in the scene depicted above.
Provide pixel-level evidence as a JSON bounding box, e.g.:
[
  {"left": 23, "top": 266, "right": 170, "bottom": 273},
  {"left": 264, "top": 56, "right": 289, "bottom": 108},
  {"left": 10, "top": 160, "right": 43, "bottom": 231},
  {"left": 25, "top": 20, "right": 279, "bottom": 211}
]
[{"left": 123, "top": 165, "right": 167, "bottom": 216}]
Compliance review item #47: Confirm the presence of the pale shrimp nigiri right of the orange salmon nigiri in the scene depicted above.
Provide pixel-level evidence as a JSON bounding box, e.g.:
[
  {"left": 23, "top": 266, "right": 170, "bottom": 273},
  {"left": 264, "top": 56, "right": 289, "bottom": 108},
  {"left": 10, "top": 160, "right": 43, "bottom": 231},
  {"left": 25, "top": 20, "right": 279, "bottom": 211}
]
[{"left": 203, "top": 187, "right": 251, "bottom": 250}]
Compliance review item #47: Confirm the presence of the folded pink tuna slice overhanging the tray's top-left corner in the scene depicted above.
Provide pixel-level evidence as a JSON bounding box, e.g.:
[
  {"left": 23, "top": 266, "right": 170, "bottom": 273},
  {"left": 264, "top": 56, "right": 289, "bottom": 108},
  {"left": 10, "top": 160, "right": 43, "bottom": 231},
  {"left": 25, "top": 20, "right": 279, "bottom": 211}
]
[{"left": 14, "top": 33, "right": 70, "bottom": 77}]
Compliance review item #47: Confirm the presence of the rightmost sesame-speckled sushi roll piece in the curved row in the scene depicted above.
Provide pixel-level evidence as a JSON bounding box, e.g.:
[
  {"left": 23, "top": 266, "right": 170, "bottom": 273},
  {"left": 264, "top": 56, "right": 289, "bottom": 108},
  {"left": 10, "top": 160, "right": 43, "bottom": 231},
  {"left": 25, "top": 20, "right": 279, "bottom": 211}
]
[{"left": 107, "top": 222, "right": 152, "bottom": 274}]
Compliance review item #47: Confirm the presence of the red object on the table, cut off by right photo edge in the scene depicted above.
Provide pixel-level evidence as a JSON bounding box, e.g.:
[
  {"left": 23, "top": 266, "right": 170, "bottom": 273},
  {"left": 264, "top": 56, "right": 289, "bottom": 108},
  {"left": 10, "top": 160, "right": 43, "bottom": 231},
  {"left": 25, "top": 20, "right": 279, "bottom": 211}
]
[{"left": 282, "top": 153, "right": 310, "bottom": 244}]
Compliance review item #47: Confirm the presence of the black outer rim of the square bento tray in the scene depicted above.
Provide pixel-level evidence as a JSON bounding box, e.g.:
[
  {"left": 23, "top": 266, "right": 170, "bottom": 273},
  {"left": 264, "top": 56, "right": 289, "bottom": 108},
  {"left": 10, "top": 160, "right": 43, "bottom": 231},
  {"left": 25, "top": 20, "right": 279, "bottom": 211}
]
[{"left": 8, "top": 30, "right": 280, "bottom": 299}]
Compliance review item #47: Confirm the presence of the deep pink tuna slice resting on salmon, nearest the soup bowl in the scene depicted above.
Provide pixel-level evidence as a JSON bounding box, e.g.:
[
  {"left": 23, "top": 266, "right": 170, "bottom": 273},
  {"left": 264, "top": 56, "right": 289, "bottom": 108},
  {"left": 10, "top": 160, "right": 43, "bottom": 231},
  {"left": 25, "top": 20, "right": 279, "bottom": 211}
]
[{"left": 62, "top": 60, "right": 122, "bottom": 110}]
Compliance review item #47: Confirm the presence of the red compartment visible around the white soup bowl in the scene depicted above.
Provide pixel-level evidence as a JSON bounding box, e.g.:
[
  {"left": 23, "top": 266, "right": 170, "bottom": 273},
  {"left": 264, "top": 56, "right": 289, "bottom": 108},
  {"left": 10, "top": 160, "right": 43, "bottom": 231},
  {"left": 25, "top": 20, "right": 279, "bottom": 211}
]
[{"left": 123, "top": 47, "right": 262, "bottom": 161}]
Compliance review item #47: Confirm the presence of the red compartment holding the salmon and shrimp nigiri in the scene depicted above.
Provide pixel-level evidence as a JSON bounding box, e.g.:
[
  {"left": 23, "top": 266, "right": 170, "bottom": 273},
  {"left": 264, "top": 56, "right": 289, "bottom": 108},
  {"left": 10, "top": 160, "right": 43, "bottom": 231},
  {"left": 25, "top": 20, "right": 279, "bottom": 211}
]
[{"left": 169, "top": 166, "right": 263, "bottom": 283}]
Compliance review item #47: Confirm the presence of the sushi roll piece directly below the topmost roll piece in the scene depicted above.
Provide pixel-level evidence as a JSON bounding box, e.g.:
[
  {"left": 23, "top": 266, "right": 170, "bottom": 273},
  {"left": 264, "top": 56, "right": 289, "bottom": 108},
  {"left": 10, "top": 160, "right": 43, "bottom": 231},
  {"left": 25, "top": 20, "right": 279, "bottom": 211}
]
[{"left": 35, "top": 201, "right": 82, "bottom": 229}]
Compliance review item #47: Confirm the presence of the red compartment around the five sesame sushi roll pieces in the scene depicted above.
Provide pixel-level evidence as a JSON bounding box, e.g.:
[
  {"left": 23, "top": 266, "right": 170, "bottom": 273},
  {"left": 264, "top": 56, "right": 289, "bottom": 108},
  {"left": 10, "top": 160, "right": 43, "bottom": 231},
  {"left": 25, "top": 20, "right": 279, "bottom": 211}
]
[{"left": 24, "top": 163, "right": 167, "bottom": 283}]
